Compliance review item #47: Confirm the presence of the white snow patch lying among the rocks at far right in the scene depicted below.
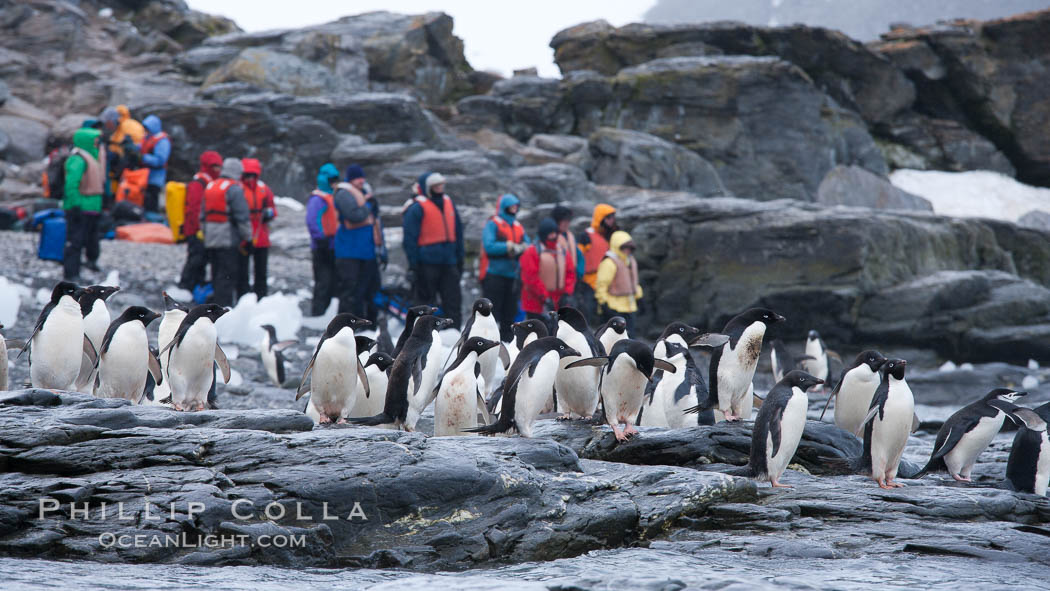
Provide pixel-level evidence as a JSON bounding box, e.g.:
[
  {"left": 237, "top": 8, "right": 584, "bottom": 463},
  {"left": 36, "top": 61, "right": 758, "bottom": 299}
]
[{"left": 889, "top": 169, "right": 1050, "bottom": 221}]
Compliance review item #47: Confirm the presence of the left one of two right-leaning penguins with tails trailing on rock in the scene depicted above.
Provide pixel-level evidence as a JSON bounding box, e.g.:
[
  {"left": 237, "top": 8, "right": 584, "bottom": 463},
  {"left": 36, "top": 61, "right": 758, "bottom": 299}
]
[{"left": 351, "top": 315, "right": 453, "bottom": 431}]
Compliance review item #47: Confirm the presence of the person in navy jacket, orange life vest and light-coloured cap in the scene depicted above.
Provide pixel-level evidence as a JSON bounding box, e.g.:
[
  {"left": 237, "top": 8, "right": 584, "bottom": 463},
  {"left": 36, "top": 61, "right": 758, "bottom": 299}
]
[{"left": 401, "top": 172, "right": 463, "bottom": 329}]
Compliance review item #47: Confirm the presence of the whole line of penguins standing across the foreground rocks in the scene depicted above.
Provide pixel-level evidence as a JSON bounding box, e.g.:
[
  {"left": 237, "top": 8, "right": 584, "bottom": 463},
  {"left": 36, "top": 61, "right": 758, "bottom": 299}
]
[{"left": 0, "top": 281, "right": 1050, "bottom": 494}]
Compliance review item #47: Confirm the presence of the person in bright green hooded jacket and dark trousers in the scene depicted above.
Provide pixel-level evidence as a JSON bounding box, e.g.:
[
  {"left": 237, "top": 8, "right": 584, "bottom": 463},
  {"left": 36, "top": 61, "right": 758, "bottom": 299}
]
[{"left": 62, "top": 128, "right": 106, "bottom": 282}]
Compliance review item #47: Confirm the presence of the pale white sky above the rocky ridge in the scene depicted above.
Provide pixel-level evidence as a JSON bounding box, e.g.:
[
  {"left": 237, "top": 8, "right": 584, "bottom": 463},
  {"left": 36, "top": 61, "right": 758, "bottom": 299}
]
[{"left": 187, "top": 0, "right": 654, "bottom": 77}]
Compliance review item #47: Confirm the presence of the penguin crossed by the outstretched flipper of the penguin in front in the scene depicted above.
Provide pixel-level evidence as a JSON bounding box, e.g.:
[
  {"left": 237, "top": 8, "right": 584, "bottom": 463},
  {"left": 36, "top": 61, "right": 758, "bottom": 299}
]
[{"left": 554, "top": 308, "right": 606, "bottom": 420}]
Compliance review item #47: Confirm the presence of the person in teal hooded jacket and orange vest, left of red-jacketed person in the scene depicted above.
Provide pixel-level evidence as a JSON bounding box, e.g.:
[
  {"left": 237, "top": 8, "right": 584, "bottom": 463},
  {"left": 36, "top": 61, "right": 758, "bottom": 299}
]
[{"left": 481, "top": 193, "right": 529, "bottom": 342}]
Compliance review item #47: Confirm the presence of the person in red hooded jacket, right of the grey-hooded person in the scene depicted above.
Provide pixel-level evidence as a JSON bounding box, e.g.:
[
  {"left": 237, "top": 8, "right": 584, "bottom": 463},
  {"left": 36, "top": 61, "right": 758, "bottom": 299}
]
[{"left": 237, "top": 159, "right": 277, "bottom": 299}]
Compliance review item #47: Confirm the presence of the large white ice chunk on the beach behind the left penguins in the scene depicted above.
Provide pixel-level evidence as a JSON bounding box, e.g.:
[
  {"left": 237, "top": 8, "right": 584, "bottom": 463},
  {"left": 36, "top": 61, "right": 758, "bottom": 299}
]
[{"left": 215, "top": 293, "right": 302, "bottom": 347}]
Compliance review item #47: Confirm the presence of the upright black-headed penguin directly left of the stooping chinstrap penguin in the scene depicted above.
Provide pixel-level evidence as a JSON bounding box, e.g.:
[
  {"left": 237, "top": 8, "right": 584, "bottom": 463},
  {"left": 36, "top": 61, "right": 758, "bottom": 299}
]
[{"left": 860, "top": 359, "right": 915, "bottom": 488}]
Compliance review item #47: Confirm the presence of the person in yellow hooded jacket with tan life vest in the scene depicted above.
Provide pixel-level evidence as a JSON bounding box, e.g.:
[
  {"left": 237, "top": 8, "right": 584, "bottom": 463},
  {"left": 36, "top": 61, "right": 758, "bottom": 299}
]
[{"left": 594, "top": 230, "right": 643, "bottom": 337}]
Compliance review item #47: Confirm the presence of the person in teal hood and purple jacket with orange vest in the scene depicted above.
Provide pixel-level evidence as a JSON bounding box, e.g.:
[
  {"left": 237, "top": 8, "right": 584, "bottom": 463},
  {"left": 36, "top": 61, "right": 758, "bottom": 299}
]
[{"left": 307, "top": 162, "right": 339, "bottom": 316}]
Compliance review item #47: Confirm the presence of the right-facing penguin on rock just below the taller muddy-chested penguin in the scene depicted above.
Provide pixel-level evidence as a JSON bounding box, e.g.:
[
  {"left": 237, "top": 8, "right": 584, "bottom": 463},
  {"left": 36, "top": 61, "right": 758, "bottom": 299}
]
[{"left": 748, "top": 370, "right": 823, "bottom": 487}]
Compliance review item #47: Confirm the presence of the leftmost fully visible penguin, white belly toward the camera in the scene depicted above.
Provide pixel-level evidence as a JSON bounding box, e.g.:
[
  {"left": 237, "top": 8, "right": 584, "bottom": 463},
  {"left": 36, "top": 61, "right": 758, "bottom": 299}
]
[{"left": 18, "top": 281, "right": 101, "bottom": 389}]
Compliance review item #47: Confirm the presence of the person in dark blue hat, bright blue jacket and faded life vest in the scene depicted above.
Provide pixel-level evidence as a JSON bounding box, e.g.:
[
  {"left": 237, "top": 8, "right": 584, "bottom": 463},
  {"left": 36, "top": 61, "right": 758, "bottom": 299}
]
[{"left": 334, "top": 164, "right": 386, "bottom": 322}]
